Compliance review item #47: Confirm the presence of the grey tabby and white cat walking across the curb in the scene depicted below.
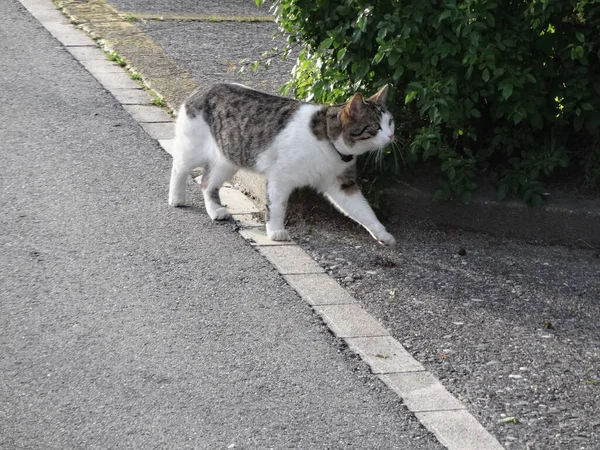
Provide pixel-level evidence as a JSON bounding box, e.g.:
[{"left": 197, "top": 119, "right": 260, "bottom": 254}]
[{"left": 169, "top": 84, "right": 396, "bottom": 246}]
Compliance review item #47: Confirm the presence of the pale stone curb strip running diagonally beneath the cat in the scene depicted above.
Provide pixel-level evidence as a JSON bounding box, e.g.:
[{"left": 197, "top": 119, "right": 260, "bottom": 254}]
[{"left": 20, "top": 0, "right": 503, "bottom": 450}]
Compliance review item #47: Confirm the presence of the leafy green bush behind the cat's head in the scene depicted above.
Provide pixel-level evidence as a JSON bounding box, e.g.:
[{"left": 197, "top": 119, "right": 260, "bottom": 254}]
[{"left": 257, "top": 0, "right": 600, "bottom": 205}]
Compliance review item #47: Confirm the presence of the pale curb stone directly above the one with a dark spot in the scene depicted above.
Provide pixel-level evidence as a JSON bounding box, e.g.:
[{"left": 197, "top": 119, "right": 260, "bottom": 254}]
[{"left": 315, "top": 304, "right": 389, "bottom": 338}]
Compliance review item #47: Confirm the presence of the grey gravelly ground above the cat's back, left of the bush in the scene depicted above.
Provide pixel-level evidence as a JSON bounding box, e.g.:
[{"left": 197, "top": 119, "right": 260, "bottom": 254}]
[{"left": 139, "top": 22, "right": 295, "bottom": 94}]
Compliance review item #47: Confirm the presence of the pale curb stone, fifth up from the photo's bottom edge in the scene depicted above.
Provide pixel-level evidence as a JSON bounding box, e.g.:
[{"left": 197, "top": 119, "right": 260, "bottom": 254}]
[{"left": 284, "top": 273, "right": 356, "bottom": 306}]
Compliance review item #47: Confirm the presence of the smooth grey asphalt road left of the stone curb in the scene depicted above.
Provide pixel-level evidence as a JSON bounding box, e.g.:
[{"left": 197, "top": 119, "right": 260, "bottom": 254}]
[{"left": 0, "top": 0, "right": 441, "bottom": 449}]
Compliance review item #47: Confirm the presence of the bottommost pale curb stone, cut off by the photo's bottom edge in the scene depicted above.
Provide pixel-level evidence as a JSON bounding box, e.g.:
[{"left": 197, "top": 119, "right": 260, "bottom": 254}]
[{"left": 415, "top": 410, "right": 504, "bottom": 450}]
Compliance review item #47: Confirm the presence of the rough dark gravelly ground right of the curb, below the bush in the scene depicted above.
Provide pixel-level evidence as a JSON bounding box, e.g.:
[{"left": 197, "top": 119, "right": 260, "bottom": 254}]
[{"left": 289, "top": 202, "right": 600, "bottom": 450}]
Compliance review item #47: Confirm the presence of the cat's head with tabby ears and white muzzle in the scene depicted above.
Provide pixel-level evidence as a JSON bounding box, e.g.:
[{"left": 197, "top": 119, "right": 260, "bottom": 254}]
[{"left": 334, "top": 85, "right": 394, "bottom": 155}]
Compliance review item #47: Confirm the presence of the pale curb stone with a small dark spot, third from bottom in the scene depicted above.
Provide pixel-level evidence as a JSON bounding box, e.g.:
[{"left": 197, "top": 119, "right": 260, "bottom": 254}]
[{"left": 346, "top": 336, "right": 425, "bottom": 374}]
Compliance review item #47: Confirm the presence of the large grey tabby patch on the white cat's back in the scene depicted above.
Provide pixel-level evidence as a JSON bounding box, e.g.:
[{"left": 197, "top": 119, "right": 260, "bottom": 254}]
[{"left": 180, "top": 83, "right": 303, "bottom": 167}]
